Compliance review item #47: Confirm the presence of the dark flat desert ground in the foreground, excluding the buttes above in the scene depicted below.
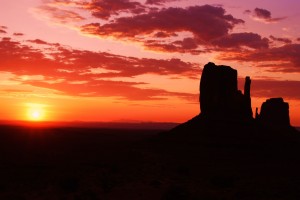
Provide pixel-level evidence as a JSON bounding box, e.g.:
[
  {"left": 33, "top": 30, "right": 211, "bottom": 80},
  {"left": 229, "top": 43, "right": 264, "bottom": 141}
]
[{"left": 0, "top": 126, "right": 300, "bottom": 200}]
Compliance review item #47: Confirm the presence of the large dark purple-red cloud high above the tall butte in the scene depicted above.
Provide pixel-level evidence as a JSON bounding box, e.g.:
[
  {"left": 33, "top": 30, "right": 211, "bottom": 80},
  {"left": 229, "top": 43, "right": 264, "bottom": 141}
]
[{"left": 81, "top": 5, "right": 244, "bottom": 53}]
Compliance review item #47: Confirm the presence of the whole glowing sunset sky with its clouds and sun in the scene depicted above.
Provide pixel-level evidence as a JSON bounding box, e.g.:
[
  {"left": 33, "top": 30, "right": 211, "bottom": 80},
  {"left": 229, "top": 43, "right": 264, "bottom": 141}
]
[{"left": 0, "top": 0, "right": 300, "bottom": 126}]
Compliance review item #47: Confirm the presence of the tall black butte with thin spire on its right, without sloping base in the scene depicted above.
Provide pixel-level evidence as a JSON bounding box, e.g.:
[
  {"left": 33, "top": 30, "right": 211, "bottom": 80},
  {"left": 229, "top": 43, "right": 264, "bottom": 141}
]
[{"left": 199, "top": 62, "right": 253, "bottom": 120}]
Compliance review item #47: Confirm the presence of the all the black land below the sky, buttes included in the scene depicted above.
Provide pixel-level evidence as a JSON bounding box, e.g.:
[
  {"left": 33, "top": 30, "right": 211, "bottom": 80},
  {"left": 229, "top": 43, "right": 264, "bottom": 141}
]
[{"left": 0, "top": 63, "right": 300, "bottom": 200}]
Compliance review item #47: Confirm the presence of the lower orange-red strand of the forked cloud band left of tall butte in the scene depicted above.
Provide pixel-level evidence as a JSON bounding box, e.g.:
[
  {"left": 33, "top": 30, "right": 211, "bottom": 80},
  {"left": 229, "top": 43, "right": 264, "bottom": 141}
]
[{"left": 24, "top": 80, "right": 198, "bottom": 100}]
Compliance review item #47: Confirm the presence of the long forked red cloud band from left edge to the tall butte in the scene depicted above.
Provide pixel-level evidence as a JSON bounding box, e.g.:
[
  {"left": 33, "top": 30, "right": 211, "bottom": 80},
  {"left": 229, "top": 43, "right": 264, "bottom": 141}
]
[{"left": 0, "top": 38, "right": 200, "bottom": 100}]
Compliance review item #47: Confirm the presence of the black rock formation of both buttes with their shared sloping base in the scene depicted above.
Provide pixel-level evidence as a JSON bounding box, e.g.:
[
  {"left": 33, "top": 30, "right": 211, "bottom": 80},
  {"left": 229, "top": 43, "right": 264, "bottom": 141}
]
[{"left": 171, "top": 62, "right": 295, "bottom": 135}]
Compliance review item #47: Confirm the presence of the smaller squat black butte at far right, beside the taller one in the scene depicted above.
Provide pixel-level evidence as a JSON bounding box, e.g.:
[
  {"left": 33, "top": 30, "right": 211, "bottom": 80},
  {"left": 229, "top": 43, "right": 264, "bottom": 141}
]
[{"left": 256, "top": 98, "right": 290, "bottom": 129}]
